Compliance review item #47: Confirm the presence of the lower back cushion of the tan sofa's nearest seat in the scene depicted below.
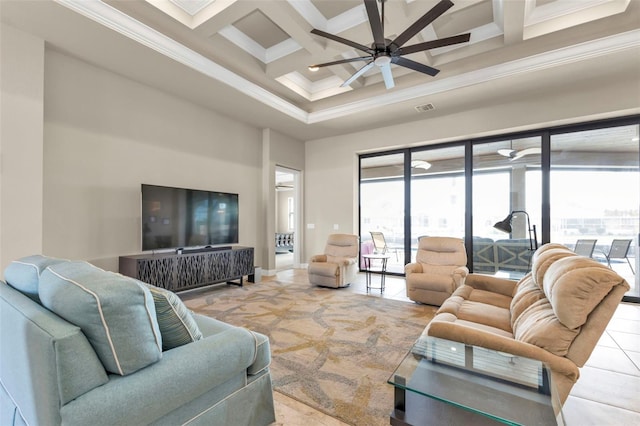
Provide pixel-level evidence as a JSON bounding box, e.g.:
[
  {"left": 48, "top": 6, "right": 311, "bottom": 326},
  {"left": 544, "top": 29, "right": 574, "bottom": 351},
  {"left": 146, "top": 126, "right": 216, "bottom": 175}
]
[{"left": 513, "top": 299, "right": 580, "bottom": 356}]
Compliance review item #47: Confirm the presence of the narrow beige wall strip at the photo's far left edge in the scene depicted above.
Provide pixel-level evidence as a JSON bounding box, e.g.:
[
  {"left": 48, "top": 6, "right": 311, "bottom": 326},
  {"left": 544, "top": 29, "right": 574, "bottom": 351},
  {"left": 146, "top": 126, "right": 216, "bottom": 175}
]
[{"left": 0, "top": 24, "right": 45, "bottom": 276}]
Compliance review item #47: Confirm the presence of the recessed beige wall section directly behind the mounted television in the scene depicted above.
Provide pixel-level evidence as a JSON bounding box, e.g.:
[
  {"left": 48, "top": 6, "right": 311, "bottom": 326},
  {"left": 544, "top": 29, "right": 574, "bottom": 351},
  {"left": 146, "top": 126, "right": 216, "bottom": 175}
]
[{"left": 43, "top": 50, "right": 262, "bottom": 271}]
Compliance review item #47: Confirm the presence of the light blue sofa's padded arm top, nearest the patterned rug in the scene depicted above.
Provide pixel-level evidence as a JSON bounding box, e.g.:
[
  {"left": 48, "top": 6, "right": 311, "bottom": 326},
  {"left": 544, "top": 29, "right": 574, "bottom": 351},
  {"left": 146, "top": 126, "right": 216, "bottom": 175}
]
[{"left": 61, "top": 327, "right": 256, "bottom": 425}]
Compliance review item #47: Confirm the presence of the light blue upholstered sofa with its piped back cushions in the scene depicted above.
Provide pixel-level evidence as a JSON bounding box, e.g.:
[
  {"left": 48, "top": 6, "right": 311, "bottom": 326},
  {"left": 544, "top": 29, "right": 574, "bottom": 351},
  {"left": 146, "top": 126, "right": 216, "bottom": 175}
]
[{"left": 0, "top": 256, "right": 275, "bottom": 426}]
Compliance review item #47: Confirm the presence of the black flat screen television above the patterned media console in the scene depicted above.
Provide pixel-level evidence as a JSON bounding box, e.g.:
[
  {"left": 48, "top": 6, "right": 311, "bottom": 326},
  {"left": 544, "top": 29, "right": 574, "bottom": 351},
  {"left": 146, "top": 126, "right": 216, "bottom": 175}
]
[{"left": 142, "top": 184, "right": 238, "bottom": 251}]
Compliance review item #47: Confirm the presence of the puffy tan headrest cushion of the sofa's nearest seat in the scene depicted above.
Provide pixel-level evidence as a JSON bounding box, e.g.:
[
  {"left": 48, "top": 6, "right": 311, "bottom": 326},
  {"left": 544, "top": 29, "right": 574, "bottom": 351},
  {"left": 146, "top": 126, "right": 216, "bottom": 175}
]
[{"left": 543, "top": 255, "right": 624, "bottom": 329}]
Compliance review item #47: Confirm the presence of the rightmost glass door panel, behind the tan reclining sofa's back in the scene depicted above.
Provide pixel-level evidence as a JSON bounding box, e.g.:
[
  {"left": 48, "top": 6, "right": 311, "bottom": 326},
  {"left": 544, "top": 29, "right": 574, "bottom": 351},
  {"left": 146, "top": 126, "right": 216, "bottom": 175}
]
[{"left": 550, "top": 125, "right": 640, "bottom": 297}]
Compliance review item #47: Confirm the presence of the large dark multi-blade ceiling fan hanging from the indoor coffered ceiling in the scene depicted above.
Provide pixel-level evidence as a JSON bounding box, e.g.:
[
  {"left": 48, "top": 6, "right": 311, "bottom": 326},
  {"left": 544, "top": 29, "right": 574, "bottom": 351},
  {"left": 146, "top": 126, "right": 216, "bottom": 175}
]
[{"left": 309, "top": 0, "right": 471, "bottom": 89}]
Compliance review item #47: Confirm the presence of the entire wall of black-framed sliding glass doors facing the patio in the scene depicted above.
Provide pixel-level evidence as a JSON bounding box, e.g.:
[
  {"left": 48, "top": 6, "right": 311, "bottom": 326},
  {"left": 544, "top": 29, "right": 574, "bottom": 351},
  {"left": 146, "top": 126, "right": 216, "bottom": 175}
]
[{"left": 360, "top": 117, "right": 640, "bottom": 301}]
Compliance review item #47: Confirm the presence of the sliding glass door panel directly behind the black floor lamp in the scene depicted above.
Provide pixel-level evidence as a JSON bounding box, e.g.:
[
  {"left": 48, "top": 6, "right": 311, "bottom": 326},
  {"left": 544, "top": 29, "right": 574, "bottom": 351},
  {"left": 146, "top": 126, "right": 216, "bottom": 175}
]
[{"left": 471, "top": 136, "right": 542, "bottom": 278}]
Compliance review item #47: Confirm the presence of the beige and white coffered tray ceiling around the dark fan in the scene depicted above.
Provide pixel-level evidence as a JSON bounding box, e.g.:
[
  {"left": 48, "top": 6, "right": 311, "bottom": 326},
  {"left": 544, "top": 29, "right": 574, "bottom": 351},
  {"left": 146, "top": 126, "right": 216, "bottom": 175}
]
[{"left": 1, "top": 0, "right": 640, "bottom": 139}]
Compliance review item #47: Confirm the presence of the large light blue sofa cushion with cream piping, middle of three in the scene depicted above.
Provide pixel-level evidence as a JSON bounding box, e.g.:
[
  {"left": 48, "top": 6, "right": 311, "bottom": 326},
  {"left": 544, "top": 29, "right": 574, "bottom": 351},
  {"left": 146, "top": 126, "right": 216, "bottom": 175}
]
[{"left": 39, "top": 262, "right": 162, "bottom": 376}]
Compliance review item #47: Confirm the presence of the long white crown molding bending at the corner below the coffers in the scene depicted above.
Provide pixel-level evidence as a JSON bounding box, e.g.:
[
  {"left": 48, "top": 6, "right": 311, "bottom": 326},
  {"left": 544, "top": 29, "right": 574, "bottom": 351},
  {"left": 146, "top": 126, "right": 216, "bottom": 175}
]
[{"left": 54, "top": 0, "right": 640, "bottom": 124}]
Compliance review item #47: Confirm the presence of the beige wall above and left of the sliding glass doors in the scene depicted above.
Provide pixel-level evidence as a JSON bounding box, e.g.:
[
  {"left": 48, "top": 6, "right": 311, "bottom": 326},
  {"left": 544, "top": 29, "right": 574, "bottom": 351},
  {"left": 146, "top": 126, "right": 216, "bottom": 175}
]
[{"left": 304, "top": 73, "right": 640, "bottom": 253}]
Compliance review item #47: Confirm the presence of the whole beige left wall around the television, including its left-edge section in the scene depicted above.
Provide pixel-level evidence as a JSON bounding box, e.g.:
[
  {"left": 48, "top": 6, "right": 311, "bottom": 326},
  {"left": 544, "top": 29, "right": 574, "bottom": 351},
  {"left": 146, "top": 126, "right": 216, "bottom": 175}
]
[{"left": 0, "top": 24, "right": 305, "bottom": 278}]
